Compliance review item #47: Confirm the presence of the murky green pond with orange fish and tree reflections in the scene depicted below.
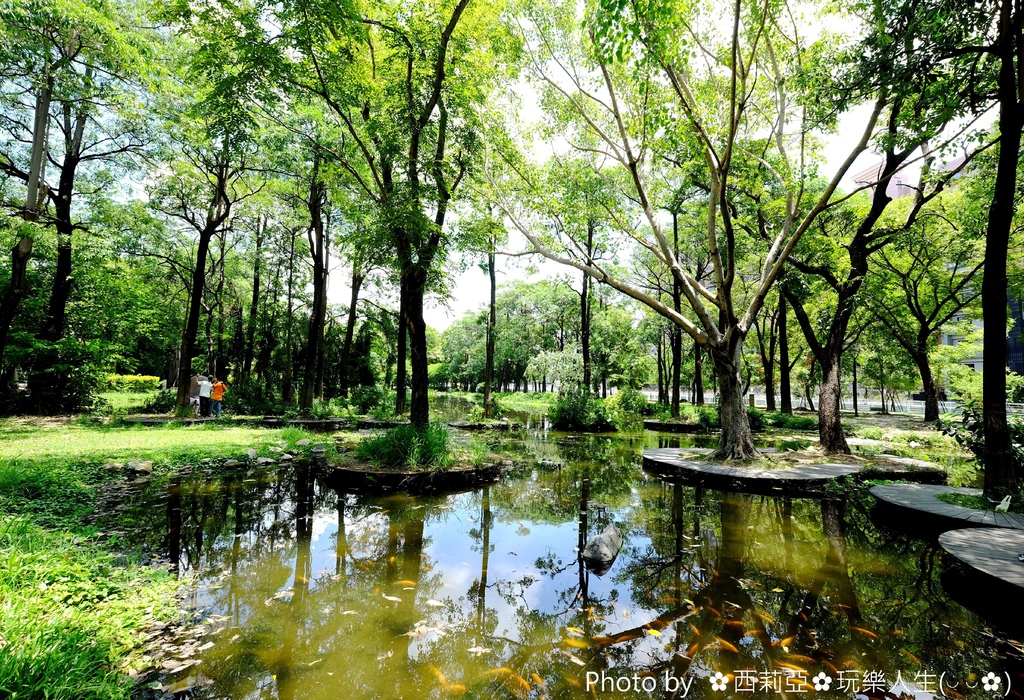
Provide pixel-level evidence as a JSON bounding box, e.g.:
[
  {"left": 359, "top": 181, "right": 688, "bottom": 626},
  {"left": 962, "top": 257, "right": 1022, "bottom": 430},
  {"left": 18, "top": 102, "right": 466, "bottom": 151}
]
[{"left": 108, "top": 417, "right": 1024, "bottom": 700}]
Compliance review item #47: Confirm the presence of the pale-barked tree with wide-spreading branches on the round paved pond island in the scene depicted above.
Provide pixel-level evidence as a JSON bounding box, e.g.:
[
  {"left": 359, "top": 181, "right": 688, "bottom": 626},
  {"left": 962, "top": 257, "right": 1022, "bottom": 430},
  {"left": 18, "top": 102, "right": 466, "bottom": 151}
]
[{"left": 490, "top": 1, "right": 887, "bottom": 460}]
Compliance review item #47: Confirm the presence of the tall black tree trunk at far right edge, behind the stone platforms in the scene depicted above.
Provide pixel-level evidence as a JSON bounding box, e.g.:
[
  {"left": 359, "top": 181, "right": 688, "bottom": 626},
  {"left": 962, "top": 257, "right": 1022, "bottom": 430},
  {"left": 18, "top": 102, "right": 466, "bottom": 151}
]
[{"left": 981, "top": 6, "right": 1024, "bottom": 498}]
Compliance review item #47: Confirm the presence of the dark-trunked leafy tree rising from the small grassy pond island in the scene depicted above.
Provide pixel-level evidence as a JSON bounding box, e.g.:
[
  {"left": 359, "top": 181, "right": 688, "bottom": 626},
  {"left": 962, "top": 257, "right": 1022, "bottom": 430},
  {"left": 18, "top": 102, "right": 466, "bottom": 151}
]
[{"left": 232, "top": 0, "right": 514, "bottom": 426}]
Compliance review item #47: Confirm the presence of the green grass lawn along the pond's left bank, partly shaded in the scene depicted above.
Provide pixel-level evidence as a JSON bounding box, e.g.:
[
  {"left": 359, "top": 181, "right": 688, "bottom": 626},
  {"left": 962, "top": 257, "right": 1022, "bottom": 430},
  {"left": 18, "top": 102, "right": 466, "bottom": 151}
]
[{"left": 0, "top": 419, "right": 323, "bottom": 700}]
